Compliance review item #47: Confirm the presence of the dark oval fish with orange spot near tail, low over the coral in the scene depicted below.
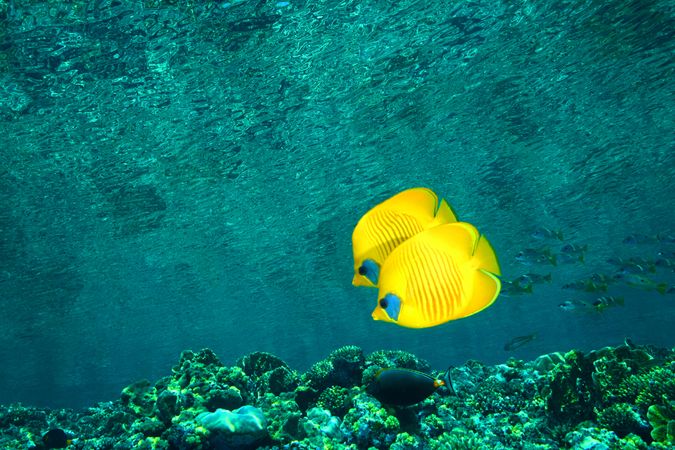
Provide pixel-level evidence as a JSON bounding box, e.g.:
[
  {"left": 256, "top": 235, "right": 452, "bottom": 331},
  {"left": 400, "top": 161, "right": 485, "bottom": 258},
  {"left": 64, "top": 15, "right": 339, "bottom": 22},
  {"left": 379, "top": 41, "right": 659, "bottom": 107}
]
[{"left": 369, "top": 367, "right": 446, "bottom": 406}]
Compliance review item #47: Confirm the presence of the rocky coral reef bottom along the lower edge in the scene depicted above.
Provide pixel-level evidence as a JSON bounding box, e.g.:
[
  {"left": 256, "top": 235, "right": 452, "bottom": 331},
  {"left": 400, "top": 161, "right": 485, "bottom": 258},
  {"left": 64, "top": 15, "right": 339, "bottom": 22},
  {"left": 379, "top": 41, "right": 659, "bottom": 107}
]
[{"left": 0, "top": 342, "right": 675, "bottom": 450}]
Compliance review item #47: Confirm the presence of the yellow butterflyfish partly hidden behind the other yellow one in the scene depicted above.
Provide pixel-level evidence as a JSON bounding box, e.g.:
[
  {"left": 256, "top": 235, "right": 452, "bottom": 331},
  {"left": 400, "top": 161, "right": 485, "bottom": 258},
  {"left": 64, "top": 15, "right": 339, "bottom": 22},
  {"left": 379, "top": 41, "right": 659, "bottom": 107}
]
[{"left": 352, "top": 188, "right": 457, "bottom": 287}]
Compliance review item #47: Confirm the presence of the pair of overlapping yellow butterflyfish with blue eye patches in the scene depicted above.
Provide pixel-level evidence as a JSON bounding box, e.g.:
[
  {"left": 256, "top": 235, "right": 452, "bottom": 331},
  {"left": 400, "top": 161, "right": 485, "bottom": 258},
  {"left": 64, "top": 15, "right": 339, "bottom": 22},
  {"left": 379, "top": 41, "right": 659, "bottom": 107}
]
[{"left": 352, "top": 188, "right": 501, "bottom": 328}]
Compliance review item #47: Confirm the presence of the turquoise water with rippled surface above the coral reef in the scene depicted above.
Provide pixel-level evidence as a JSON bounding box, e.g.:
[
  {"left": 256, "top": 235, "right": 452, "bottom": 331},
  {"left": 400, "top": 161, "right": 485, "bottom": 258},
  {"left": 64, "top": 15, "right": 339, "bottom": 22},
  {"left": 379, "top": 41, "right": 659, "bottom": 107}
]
[{"left": 0, "top": 0, "right": 675, "bottom": 406}]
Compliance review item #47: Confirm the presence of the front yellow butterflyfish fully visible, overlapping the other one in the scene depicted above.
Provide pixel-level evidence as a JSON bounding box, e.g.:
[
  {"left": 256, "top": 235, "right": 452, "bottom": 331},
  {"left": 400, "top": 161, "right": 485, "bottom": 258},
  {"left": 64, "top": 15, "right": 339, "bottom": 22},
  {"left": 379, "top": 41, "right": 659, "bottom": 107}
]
[{"left": 372, "top": 222, "right": 501, "bottom": 328}]
